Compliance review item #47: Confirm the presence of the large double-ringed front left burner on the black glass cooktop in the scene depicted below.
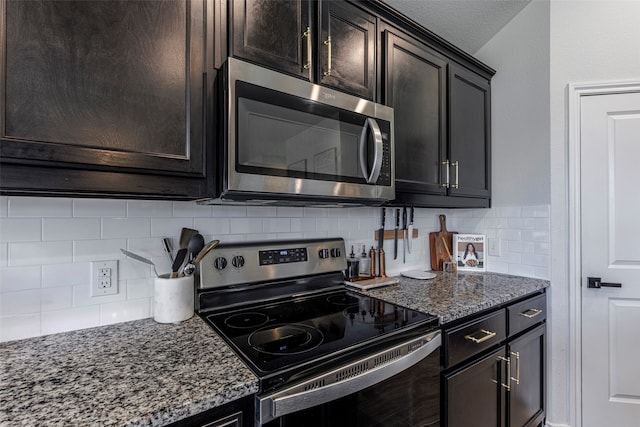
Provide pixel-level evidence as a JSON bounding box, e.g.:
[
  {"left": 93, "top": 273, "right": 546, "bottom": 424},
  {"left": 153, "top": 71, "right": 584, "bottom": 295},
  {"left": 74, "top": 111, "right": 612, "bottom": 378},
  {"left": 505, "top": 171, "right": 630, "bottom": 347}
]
[{"left": 249, "top": 324, "right": 324, "bottom": 354}]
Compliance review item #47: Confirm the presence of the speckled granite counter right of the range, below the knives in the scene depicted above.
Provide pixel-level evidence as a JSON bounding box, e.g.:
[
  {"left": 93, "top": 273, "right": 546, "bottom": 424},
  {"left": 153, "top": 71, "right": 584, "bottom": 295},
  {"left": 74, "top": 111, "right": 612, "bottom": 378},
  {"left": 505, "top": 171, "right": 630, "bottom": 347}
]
[{"left": 360, "top": 272, "right": 549, "bottom": 324}]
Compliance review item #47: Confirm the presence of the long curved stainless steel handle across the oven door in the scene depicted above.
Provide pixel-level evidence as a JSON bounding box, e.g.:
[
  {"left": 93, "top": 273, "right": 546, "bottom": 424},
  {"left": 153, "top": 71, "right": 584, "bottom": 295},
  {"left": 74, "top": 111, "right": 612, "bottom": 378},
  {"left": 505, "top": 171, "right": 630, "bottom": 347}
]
[{"left": 257, "top": 330, "right": 442, "bottom": 425}]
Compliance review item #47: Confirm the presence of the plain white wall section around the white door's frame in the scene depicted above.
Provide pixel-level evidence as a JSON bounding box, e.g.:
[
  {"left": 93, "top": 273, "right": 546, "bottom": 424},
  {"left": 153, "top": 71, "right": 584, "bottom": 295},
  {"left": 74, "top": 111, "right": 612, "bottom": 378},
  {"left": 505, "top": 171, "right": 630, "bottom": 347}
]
[{"left": 549, "top": 0, "right": 640, "bottom": 425}]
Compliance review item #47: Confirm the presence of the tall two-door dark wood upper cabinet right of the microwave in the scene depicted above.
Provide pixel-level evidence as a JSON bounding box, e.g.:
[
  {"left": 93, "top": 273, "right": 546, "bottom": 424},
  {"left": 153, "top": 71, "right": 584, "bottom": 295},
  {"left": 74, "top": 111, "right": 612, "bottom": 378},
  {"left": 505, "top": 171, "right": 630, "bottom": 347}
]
[{"left": 383, "top": 25, "right": 491, "bottom": 207}]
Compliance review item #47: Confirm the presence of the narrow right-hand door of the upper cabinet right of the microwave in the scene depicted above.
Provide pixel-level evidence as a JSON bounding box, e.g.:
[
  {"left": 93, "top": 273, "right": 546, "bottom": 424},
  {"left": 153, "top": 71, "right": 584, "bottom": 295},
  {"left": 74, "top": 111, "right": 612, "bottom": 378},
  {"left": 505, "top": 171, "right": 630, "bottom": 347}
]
[{"left": 449, "top": 64, "right": 491, "bottom": 198}]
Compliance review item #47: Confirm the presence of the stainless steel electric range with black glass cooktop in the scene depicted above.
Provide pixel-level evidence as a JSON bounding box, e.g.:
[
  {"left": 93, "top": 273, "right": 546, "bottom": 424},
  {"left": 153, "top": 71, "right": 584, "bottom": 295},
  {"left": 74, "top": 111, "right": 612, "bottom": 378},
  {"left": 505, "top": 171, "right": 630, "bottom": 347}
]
[{"left": 196, "top": 238, "right": 440, "bottom": 427}]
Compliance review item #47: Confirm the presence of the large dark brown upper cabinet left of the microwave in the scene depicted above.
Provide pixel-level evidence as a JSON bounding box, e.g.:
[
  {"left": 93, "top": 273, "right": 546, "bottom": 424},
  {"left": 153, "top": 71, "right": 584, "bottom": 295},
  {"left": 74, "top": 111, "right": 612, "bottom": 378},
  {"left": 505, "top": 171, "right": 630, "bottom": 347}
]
[{"left": 0, "top": 0, "right": 214, "bottom": 198}]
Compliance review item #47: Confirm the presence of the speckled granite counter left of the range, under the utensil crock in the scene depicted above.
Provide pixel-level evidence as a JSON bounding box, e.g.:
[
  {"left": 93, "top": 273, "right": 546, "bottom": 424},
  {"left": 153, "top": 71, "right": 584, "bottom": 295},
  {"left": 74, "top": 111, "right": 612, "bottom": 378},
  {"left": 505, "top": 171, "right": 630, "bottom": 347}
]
[{"left": 0, "top": 316, "right": 258, "bottom": 426}]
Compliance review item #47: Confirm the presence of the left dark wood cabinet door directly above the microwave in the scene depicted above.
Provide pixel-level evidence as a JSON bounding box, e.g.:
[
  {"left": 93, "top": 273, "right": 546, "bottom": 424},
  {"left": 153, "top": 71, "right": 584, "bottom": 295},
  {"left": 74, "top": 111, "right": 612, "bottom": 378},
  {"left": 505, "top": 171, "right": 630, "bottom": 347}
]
[{"left": 232, "top": 0, "right": 312, "bottom": 80}]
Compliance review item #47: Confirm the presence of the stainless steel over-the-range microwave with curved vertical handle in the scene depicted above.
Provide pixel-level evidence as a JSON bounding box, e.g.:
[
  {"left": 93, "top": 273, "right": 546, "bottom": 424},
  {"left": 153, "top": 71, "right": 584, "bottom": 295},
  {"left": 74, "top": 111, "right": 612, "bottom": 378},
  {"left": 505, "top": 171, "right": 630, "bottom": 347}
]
[{"left": 203, "top": 58, "right": 395, "bottom": 206}]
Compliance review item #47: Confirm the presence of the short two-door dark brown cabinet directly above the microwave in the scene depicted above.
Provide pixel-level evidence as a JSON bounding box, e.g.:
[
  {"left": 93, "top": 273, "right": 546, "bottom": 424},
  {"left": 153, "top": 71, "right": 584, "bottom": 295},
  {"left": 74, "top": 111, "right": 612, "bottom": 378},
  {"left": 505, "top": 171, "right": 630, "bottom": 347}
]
[{"left": 230, "top": 0, "right": 376, "bottom": 99}]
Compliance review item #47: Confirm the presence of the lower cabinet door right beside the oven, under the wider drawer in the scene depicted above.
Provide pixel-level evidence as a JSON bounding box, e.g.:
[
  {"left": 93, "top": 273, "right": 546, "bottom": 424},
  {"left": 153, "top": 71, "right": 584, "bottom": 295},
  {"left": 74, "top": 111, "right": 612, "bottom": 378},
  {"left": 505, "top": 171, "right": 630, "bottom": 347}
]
[{"left": 443, "top": 346, "right": 505, "bottom": 427}]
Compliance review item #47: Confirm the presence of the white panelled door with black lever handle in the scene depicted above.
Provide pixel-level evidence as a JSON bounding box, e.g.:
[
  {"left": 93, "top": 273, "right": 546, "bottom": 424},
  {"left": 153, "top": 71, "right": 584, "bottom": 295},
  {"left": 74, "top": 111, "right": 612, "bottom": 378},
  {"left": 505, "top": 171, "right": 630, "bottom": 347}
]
[{"left": 580, "top": 93, "right": 640, "bottom": 427}]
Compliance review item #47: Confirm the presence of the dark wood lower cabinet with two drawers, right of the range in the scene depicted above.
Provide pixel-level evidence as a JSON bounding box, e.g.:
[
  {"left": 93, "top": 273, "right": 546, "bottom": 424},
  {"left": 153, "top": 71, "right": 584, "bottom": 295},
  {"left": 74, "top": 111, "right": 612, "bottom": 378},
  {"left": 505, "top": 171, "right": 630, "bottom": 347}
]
[{"left": 442, "top": 294, "right": 546, "bottom": 427}]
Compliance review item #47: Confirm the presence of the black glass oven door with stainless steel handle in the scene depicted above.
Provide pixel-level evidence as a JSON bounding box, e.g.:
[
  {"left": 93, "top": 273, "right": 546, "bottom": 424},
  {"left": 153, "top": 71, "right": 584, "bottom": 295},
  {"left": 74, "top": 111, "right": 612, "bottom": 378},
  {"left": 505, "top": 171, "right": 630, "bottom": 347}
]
[{"left": 256, "top": 331, "right": 441, "bottom": 427}]
